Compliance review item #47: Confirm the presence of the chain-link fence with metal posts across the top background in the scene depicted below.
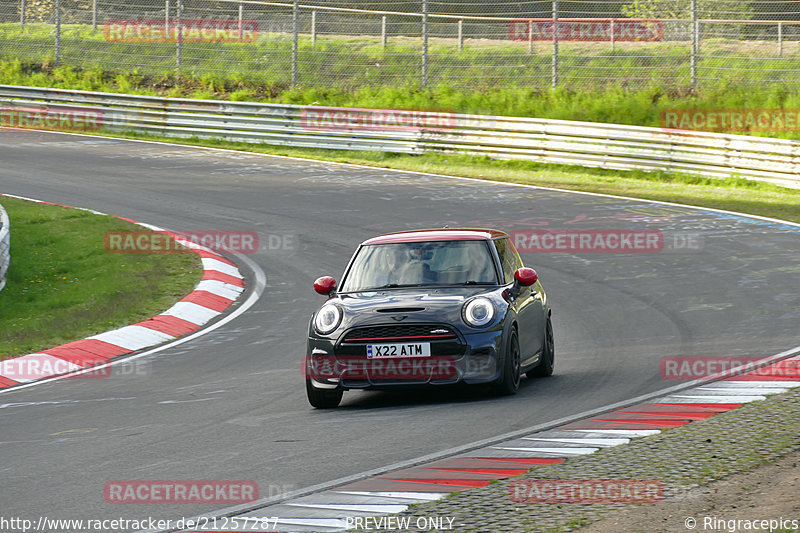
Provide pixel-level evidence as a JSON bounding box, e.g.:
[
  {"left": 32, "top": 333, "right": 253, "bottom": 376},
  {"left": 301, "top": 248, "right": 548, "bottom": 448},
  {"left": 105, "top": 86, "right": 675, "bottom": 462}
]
[{"left": 0, "top": 0, "right": 800, "bottom": 90}]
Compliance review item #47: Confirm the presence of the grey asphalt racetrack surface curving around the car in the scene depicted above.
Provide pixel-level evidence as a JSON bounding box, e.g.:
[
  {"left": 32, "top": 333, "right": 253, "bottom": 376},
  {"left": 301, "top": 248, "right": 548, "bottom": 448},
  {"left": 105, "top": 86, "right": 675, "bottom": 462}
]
[{"left": 0, "top": 131, "right": 800, "bottom": 519}]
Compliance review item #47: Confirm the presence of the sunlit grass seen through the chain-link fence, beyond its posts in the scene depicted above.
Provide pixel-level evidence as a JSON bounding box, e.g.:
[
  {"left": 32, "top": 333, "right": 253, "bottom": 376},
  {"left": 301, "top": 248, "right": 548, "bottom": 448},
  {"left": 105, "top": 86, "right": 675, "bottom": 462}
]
[{"left": 0, "top": 23, "right": 800, "bottom": 91}]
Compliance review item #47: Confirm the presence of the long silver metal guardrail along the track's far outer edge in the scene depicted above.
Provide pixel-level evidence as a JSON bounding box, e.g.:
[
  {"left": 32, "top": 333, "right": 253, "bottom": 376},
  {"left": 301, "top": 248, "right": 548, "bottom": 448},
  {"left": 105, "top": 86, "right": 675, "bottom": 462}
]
[{"left": 0, "top": 85, "right": 800, "bottom": 188}]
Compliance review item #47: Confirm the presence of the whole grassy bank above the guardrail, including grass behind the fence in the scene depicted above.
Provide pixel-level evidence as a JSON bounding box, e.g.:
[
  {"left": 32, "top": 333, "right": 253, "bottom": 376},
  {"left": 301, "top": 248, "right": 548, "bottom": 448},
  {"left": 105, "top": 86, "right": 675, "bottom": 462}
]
[{"left": 0, "top": 23, "right": 800, "bottom": 143}]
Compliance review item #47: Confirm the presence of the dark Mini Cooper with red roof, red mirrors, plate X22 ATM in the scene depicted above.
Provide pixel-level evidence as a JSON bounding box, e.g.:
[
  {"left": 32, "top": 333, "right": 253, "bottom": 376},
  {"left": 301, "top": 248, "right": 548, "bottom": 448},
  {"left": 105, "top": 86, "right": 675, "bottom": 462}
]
[{"left": 303, "top": 229, "right": 555, "bottom": 408}]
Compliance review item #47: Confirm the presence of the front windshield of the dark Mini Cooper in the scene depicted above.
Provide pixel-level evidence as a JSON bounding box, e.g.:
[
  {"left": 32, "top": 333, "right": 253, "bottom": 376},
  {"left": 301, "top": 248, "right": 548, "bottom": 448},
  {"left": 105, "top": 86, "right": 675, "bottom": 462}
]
[{"left": 341, "top": 240, "right": 497, "bottom": 292}]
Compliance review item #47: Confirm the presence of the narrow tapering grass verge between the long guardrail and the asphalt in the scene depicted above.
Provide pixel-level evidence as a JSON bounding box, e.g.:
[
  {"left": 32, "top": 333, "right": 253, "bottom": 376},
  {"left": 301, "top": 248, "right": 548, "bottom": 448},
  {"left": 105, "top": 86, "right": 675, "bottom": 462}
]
[{"left": 70, "top": 129, "right": 800, "bottom": 223}]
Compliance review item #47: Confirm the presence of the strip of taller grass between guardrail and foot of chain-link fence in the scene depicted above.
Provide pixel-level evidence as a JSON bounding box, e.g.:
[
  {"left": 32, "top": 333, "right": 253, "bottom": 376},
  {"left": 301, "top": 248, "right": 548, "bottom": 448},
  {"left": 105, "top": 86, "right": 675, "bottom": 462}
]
[{"left": 0, "top": 59, "right": 800, "bottom": 139}]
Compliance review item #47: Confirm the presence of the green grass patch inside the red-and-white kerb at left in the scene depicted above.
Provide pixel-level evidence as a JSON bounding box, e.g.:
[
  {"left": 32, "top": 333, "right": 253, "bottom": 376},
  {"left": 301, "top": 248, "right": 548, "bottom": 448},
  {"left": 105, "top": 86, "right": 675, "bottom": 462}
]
[{"left": 0, "top": 196, "right": 202, "bottom": 358}]
